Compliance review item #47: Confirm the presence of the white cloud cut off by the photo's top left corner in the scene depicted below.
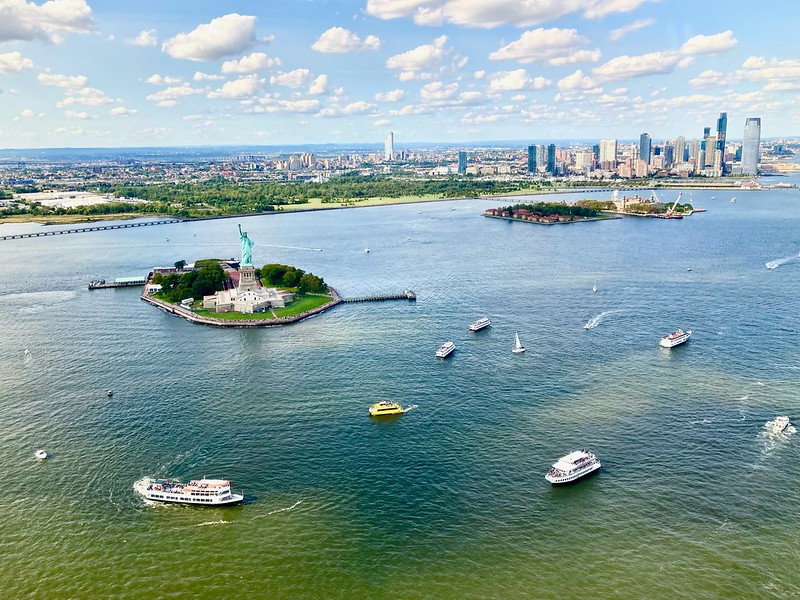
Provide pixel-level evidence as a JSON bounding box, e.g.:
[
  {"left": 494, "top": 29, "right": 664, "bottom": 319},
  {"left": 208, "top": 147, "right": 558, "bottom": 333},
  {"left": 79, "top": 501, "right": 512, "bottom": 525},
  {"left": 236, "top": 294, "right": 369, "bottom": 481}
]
[{"left": 0, "top": 0, "right": 94, "bottom": 44}]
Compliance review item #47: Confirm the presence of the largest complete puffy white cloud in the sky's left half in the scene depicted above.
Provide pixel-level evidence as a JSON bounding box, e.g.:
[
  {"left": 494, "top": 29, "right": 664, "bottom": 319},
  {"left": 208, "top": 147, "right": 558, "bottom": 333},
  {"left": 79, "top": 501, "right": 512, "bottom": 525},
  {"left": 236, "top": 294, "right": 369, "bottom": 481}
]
[{"left": 161, "top": 13, "right": 256, "bottom": 61}]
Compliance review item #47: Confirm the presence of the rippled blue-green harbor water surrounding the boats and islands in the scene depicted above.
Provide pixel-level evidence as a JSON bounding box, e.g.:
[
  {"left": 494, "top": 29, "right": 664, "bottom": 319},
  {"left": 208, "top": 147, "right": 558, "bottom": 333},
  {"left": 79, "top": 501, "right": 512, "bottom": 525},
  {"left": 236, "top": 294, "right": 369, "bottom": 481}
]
[{"left": 0, "top": 184, "right": 800, "bottom": 599}]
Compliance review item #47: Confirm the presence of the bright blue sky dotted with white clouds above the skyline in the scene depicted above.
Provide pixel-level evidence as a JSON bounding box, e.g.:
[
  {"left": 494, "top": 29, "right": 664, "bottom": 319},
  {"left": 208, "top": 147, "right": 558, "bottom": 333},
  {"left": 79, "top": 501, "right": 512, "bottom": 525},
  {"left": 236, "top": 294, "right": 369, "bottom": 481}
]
[{"left": 0, "top": 0, "right": 800, "bottom": 148}]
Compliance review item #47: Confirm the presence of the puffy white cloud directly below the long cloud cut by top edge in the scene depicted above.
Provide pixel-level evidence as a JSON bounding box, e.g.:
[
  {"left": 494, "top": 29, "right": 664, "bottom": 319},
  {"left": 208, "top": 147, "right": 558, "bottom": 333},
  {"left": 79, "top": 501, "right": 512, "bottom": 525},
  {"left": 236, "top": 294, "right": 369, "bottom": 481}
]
[{"left": 489, "top": 27, "right": 601, "bottom": 65}]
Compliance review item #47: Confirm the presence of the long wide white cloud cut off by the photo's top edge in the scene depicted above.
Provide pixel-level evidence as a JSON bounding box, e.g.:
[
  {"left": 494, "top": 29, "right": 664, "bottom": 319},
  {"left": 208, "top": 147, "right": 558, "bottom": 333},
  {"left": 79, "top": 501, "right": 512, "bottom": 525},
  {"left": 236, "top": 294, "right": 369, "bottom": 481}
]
[{"left": 367, "top": 0, "right": 645, "bottom": 29}]
